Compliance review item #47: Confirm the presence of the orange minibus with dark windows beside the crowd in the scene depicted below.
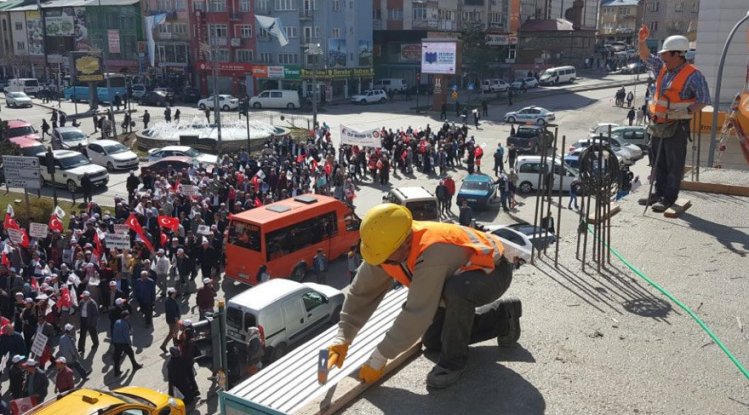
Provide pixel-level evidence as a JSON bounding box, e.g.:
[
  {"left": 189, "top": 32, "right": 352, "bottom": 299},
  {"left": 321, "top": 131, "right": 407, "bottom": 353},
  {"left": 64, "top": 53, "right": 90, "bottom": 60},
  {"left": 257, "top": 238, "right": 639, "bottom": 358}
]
[{"left": 225, "top": 194, "right": 361, "bottom": 285}]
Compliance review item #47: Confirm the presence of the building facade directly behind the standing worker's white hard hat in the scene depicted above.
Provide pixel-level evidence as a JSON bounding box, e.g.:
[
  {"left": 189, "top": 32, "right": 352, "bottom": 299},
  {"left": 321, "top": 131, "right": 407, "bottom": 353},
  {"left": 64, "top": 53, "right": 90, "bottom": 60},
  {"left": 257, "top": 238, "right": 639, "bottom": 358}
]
[{"left": 642, "top": 0, "right": 700, "bottom": 51}]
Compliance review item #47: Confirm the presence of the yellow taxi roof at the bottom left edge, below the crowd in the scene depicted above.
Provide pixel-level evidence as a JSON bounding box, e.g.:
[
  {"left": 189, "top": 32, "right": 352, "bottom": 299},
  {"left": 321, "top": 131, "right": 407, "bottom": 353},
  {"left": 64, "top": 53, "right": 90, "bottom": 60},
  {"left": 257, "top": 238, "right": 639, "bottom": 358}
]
[{"left": 26, "top": 386, "right": 186, "bottom": 415}]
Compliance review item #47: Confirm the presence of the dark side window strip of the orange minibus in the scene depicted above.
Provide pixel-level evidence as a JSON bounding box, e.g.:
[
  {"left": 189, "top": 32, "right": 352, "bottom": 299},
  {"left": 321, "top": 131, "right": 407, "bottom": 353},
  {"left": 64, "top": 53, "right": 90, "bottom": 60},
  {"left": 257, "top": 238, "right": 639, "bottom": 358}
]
[{"left": 265, "top": 212, "right": 338, "bottom": 261}]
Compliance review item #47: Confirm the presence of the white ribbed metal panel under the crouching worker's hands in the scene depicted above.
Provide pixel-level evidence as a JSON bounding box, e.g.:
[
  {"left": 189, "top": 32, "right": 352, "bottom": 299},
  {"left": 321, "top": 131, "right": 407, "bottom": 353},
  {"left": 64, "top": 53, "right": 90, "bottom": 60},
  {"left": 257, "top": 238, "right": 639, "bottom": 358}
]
[{"left": 222, "top": 289, "right": 408, "bottom": 414}]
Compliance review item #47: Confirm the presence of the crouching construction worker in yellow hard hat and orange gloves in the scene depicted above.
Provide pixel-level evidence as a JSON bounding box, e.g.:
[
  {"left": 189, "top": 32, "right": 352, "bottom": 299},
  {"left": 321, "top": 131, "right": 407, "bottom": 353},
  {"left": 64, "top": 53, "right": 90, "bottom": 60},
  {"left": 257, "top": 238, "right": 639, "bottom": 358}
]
[{"left": 328, "top": 203, "right": 521, "bottom": 388}]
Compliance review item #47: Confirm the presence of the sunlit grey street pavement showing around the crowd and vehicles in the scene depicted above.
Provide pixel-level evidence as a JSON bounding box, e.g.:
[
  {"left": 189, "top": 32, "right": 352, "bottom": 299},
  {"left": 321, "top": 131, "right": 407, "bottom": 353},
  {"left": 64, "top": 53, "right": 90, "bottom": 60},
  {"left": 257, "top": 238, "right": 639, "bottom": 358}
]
[{"left": 2, "top": 76, "right": 668, "bottom": 414}]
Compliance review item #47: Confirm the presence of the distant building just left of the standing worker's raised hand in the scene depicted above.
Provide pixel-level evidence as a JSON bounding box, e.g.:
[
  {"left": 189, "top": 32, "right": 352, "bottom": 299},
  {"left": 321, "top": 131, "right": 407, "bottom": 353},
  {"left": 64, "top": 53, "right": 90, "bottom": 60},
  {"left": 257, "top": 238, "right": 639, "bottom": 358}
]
[{"left": 598, "top": 0, "right": 643, "bottom": 45}]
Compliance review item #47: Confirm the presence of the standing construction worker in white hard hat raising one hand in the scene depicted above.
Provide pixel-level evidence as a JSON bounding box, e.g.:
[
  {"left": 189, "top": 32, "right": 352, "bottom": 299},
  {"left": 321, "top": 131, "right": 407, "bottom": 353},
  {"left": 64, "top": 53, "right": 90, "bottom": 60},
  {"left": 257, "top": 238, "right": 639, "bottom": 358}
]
[{"left": 639, "top": 25, "right": 710, "bottom": 212}]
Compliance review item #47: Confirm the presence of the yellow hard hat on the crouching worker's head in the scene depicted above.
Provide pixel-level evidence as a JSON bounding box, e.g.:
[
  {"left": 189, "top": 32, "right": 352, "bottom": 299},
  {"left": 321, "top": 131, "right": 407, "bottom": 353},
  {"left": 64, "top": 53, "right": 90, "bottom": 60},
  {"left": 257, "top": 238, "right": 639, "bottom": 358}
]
[{"left": 359, "top": 203, "right": 413, "bottom": 265}]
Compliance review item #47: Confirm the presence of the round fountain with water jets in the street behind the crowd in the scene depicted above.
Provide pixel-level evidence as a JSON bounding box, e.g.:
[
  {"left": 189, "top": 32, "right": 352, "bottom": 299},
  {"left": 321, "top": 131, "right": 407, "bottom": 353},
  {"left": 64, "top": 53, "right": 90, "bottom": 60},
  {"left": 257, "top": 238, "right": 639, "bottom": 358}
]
[{"left": 136, "top": 116, "right": 290, "bottom": 153}]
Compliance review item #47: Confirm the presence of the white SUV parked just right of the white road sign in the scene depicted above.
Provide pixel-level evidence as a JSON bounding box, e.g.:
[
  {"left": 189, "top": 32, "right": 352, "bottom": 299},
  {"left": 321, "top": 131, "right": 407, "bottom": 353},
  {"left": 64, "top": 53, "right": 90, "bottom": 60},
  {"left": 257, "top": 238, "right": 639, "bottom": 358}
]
[{"left": 37, "top": 150, "right": 109, "bottom": 193}]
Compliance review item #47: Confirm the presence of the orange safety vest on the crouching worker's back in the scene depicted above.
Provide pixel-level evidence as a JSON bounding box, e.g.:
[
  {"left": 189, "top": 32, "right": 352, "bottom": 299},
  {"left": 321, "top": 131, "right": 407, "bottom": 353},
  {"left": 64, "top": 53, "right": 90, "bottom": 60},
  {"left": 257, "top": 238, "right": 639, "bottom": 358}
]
[{"left": 380, "top": 221, "right": 504, "bottom": 287}]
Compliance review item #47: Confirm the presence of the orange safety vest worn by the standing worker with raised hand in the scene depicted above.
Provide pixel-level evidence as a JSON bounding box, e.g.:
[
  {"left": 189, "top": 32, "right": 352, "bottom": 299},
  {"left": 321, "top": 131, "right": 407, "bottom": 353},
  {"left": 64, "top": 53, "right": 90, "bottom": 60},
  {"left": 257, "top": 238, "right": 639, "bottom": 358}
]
[{"left": 648, "top": 63, "right": 697, "bottom": 124}]
